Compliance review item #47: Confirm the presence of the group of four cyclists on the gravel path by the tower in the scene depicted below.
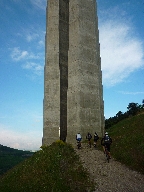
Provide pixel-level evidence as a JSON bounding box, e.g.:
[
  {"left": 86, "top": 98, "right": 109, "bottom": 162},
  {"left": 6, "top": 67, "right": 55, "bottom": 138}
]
[{"left": 76, "top": 132, "right": 112, "bottom": 158}]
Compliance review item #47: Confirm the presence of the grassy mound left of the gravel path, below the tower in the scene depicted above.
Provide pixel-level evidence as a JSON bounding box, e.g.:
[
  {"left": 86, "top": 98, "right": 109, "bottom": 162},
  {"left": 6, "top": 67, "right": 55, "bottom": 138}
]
[{"left": 0, "top": 141, "right": 95, "bottom": 192}]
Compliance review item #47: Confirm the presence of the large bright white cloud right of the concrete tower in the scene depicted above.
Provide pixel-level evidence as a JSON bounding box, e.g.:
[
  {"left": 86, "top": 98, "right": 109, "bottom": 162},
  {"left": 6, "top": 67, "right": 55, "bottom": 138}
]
[{"left": 99, "top": 12, "right": 144, "bottom": 86}]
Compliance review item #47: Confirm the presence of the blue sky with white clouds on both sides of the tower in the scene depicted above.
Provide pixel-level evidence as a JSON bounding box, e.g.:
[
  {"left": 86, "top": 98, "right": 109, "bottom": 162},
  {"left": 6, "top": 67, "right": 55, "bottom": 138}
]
[{"left": 0, "top": 0, "right": 144, "bottom": 150}]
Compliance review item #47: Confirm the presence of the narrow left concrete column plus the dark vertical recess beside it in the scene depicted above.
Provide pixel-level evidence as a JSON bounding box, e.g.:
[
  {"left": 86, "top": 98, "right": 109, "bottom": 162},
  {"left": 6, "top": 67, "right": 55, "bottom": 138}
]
[{"left": 43, "top": 0, "right": 69, "bottom": 144}]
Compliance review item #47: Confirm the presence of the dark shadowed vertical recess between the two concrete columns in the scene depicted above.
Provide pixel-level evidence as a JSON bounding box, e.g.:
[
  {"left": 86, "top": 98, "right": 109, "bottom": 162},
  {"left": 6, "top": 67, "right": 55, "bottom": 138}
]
[{"left": 59, "top": 0, "right": 69, "bottom": 140}]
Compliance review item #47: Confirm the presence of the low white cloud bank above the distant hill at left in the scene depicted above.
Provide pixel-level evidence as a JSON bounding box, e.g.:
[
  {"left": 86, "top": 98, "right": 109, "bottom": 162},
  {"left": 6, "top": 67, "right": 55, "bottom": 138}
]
[{"left": 0, "top": 124, "right": 42, "bottom": 150}]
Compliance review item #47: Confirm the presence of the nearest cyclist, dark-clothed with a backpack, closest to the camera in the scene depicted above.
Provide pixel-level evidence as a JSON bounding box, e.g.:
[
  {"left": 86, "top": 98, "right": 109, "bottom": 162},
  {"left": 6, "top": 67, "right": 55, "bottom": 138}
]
[{"left": 101, "top": 132, "right": 112, "bottom": 157}]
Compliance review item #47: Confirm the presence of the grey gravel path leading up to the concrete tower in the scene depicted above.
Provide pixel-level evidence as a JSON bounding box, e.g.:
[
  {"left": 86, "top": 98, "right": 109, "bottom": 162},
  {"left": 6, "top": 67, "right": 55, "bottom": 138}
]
[{"left": 76, "top": 144, "right": 144, "bottom": 192}]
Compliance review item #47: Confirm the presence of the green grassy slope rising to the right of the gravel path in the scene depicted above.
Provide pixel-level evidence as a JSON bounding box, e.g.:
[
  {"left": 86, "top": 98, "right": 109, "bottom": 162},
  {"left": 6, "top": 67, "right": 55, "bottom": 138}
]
[{"left": 108, "top": 114, "right": 144, "bottom": 174}]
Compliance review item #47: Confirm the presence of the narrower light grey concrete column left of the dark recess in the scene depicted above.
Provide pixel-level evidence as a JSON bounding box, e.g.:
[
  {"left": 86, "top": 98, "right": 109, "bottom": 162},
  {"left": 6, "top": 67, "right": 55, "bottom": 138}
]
[{"left": 43, "top": 0, "right": 60, "bottom": 145}]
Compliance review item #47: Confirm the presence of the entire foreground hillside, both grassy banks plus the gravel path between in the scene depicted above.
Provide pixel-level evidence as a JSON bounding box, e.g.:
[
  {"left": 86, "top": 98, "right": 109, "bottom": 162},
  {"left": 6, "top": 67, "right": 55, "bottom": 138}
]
[{"left": 0, "top": 113, "right": 144, "bottom": 192}]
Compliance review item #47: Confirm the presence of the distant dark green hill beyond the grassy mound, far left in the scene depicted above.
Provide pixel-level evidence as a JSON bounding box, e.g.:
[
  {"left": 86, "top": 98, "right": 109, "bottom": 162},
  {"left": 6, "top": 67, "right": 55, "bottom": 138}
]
[{"left": 0, "top": 144, "right": 33, "bottom": 175}]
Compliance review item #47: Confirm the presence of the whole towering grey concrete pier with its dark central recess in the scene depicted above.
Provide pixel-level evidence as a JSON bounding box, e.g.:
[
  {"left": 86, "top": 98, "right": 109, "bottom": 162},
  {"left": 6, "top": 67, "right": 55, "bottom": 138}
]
[{"left": 43, "top": 0, "right": 104, "bottom": 145}]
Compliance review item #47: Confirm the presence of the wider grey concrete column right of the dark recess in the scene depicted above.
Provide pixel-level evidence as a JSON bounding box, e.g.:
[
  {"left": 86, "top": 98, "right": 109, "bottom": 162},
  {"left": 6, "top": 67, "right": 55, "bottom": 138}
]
[{"left": 67, "top": 0, "right": 104, "bottom": 142}]
